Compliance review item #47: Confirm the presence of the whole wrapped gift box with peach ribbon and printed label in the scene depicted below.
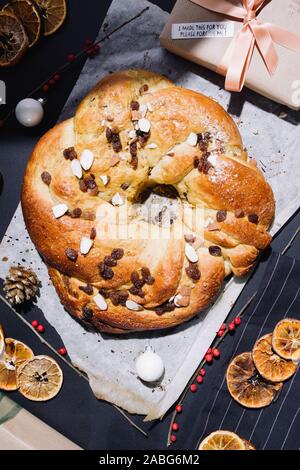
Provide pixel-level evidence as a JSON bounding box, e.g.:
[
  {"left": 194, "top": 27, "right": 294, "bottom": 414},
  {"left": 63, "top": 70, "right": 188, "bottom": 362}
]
[{"left": 160, "top": 0, "right": 300, "bottom": 109}]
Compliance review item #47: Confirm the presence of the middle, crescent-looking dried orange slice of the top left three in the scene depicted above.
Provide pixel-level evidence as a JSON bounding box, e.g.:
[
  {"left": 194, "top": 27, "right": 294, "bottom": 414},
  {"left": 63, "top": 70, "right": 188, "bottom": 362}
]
[{"left": 2, "top": 0, "right": 42, "bottom": 47}]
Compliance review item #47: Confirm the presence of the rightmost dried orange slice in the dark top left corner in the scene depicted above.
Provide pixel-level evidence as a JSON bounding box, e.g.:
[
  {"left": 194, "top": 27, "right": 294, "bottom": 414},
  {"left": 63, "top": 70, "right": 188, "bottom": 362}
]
[{"left": 35, "top": 0, "right": 67, "bottom": 36}]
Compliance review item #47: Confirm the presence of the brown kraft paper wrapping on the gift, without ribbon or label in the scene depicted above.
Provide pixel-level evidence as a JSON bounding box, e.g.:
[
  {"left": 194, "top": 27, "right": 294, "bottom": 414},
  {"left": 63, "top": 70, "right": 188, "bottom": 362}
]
[{"left": 160, "top": 0, "right": 300, "bottom": 109}]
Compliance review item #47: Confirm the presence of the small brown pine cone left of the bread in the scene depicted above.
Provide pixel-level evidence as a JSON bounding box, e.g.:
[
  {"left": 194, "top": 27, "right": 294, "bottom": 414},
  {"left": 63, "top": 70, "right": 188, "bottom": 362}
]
[{"left": 3, "top": 266, "right": 40, "bottom": 305}]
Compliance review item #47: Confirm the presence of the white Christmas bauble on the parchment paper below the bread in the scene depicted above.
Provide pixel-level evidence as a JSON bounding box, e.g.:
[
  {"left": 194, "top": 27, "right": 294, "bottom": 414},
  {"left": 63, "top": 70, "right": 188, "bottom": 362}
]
[{"left": 135, "top": 347, "right": 165, "bottom": 382}]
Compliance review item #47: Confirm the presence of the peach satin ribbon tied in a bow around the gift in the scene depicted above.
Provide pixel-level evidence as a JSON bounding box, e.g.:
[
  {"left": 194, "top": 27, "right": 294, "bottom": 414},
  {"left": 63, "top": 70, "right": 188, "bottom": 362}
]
[{"left": 192, "top": 0, "right": 300, "bottom": 91}]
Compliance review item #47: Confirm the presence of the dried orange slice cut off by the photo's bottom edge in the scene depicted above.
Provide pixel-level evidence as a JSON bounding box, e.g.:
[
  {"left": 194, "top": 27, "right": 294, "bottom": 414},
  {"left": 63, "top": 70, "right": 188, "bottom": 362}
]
[{"left": 199, "top": 430, "right": 246, "bottom": 450}]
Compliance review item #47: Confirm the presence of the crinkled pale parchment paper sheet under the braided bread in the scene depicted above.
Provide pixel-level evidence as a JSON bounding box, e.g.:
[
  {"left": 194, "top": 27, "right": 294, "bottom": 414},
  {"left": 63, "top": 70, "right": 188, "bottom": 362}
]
[{"left": 0, "top": 0, "right": 300, "bottom": 419}]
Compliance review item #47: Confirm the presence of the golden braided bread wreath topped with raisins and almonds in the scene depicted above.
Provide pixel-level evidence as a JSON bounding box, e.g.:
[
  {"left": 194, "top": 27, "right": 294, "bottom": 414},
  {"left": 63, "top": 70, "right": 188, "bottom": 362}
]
[{"left": 22, "top": 70, "right": 274, "bottom": 333}]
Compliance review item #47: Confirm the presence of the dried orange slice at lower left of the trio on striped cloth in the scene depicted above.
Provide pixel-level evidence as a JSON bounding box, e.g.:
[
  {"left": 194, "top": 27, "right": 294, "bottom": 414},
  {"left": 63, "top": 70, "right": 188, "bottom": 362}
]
[{"left": 226, "top": 352, "right": 283, "bottom": 408}]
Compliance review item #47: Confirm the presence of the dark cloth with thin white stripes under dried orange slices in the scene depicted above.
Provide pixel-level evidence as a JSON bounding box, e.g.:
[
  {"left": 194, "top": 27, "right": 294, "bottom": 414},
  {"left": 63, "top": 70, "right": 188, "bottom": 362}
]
[{"left": 178, "top": 253, "right": 300, "bottom": 450}]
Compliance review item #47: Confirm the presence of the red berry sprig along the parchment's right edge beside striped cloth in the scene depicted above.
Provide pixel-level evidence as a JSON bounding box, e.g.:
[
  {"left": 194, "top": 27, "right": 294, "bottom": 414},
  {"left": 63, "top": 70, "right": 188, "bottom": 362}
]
[{"left": 167, "top": 293, "right": 256, "bottom": 446}]
